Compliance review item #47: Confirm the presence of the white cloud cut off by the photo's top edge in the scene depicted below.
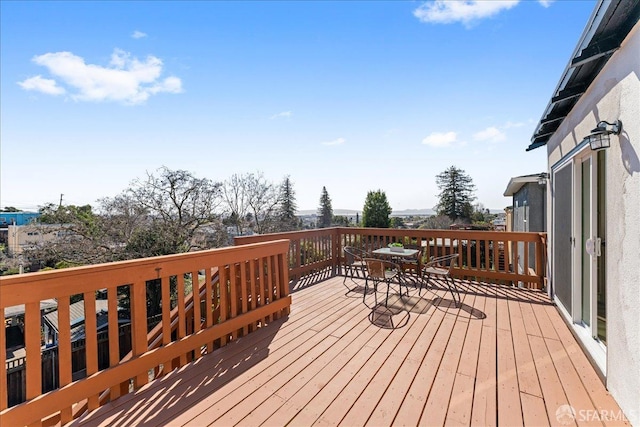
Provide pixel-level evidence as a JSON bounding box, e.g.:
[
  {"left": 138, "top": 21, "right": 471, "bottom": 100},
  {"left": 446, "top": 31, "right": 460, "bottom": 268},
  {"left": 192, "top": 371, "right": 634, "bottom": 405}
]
[{"left": 413, "top": 0, "right": 520, "bottom": 26}]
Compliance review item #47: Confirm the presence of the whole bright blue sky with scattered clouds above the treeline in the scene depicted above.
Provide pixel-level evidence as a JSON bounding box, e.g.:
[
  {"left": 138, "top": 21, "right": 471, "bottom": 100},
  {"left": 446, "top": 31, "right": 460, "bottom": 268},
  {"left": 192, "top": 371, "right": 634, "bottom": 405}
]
[{"left": 0, "top": 0, "right": 595, "bottom": 210}]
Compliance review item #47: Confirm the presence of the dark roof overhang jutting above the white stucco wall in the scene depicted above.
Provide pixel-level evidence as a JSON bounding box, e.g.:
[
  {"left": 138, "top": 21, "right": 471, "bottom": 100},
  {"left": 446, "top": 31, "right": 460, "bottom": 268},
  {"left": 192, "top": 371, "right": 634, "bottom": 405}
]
[{"left": 527, "top": 0, "right": 640, "bottom": 151}]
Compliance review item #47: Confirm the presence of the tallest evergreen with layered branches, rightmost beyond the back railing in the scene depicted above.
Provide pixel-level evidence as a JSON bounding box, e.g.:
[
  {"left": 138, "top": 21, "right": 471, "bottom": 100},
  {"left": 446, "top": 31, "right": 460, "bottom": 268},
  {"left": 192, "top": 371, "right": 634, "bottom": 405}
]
[{"left": 436, "top": 166, "right": 476, "bottom": 222}]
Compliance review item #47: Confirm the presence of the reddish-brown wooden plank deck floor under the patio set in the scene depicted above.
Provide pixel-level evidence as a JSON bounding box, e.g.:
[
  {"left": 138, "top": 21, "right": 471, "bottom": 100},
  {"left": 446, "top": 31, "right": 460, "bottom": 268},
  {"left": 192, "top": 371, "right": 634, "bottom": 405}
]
[{"left": 67, "top": 276, "right": 621, "bottom": 426}]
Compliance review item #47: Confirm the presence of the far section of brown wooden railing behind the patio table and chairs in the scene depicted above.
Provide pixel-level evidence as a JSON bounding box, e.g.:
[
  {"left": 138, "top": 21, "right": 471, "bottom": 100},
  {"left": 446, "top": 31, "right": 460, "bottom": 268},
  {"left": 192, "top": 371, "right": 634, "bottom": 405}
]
[{"left": 235, "top": 227, "right": 546, "bottom": 289}]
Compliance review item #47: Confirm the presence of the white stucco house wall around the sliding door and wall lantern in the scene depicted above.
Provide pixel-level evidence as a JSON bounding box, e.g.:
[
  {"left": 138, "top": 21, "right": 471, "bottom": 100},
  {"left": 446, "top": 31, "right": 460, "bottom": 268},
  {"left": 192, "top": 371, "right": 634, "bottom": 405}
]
[{"left": 547, "top": 23, "right": 640, "bottom": 425}]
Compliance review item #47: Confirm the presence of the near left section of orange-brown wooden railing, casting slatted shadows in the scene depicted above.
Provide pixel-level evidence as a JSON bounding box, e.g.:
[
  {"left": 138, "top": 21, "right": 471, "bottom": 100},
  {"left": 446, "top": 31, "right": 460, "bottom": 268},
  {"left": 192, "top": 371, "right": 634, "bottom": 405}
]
[{"left": 0, "top": 239, "right": 291, "bottom": 426}]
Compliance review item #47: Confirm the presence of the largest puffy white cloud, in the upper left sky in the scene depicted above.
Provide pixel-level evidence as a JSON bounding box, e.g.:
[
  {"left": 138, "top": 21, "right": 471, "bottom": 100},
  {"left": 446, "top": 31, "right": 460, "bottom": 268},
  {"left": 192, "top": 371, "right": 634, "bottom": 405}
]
[{"left": 18, "top": 49, "right": 182, "bottom": 105}]
